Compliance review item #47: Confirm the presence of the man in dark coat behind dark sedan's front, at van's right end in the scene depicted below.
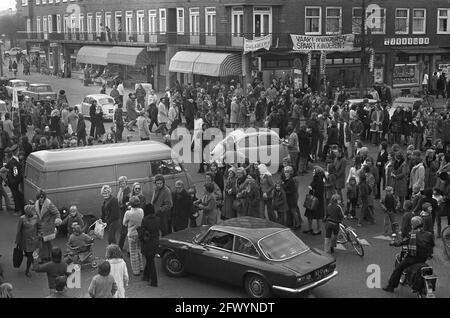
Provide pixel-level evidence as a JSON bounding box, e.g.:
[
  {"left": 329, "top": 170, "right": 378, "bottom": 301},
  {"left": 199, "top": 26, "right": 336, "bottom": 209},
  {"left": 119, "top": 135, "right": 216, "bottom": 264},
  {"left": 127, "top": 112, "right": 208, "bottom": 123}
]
[{"left": 172, "top": 180, "right": 193, "bottom": 232}]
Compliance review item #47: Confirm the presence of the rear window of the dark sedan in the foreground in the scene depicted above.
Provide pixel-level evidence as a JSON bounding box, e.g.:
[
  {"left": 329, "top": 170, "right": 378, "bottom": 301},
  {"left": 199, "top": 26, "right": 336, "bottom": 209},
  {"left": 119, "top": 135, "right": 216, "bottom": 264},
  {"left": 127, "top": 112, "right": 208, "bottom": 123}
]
[{"left": 258, "top": 230, "right": 309, "bottom": 261}]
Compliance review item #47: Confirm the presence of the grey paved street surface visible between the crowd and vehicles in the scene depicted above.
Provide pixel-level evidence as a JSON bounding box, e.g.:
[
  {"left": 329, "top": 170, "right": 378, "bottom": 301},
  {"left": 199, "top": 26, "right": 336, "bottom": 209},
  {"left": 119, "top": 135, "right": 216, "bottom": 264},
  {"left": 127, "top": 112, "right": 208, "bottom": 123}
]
[{"left": 0, "top": 67, "right": 450, "bottom": 298}]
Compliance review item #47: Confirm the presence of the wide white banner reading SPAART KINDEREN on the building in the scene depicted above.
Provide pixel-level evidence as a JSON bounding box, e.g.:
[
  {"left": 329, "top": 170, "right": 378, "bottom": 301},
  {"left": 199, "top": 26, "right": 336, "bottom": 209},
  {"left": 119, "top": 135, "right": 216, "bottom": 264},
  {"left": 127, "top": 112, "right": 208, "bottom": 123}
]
[{"left": 291, "top": 34, "right": 355, "bottom": 51}]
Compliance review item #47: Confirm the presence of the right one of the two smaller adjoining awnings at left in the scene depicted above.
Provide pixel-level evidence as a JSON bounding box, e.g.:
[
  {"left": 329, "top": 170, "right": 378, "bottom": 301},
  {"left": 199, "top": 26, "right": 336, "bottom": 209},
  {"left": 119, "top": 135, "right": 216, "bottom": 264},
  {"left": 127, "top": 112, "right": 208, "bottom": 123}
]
[{"left": 106, "top": 46, "right": 150, "bottom": 66}]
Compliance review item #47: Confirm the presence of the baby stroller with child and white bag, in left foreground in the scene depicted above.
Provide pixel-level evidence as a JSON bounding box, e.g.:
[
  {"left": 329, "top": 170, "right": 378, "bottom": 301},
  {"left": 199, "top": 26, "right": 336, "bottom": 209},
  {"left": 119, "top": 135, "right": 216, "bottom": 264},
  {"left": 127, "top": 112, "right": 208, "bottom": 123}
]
[{"left": 64, "top": 220, "right": 106, "bottom": 269}]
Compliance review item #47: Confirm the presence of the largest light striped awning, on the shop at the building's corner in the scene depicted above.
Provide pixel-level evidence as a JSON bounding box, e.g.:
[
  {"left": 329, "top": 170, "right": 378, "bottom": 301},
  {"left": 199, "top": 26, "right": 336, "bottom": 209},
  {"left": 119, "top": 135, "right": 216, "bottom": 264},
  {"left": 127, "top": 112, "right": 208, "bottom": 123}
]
[{"left": 169, "top": 51, "right": 242, "bottom": 77}]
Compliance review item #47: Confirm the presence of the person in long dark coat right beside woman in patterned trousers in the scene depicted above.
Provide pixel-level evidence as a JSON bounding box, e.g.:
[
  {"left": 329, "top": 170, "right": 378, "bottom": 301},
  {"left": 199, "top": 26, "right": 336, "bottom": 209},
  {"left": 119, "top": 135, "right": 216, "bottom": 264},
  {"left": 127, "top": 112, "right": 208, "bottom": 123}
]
[{"left": 139, "top": 203, "right": 160, "bottom": 287}]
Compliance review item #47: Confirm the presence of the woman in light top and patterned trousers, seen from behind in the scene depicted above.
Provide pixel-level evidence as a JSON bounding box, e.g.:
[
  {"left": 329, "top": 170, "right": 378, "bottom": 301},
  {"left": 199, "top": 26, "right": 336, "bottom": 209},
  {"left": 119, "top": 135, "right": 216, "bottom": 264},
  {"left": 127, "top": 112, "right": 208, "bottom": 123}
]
[{"left": 123, "top": 196, "right": 144, "bottom": 276}]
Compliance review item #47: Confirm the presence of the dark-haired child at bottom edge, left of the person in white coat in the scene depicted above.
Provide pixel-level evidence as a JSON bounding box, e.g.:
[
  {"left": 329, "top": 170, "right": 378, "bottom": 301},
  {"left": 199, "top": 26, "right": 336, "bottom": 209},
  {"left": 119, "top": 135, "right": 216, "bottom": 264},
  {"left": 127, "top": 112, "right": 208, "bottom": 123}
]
[{"left": 88, "top": 261, "right": 117, "bottom": 298}]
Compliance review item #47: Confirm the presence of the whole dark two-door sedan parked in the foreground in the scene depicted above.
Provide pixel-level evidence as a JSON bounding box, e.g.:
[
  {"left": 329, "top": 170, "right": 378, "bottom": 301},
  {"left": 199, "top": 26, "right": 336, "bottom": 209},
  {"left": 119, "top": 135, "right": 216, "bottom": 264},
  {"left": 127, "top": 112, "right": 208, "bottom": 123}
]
[{"left": 159, "top": 217, "right": 338, "bottom": 298}]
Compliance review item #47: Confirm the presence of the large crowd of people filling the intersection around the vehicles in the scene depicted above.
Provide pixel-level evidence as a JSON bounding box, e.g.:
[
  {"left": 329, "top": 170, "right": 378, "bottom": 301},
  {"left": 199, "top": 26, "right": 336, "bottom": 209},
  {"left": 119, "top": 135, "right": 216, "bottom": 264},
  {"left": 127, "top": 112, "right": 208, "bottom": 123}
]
[{"left": 0, "top": 69, "right": 450, "bottom": 297}]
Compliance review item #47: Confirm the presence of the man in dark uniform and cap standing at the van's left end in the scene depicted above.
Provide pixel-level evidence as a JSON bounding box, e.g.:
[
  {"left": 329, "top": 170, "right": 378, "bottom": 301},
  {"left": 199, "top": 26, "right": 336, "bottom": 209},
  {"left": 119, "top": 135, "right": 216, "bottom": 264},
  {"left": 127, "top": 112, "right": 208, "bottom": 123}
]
[{"left": 0, "top": 145, "right": 24, "bottom": 216}]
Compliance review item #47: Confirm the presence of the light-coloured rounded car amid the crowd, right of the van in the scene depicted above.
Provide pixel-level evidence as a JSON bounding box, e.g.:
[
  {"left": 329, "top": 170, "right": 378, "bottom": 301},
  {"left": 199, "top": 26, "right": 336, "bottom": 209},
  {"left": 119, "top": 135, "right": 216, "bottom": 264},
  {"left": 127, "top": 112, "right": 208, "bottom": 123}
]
[{"left": 209, "top": 128, "right": 289, "bottom": 173}]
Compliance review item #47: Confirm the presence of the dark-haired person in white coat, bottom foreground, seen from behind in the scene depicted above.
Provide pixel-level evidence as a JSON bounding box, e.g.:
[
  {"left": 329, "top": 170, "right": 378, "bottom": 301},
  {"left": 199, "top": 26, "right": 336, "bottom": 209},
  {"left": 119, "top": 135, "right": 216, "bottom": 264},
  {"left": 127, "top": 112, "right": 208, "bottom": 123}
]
[{"left": 105, "top": 244, "right": 129, "bottom": 298}]
